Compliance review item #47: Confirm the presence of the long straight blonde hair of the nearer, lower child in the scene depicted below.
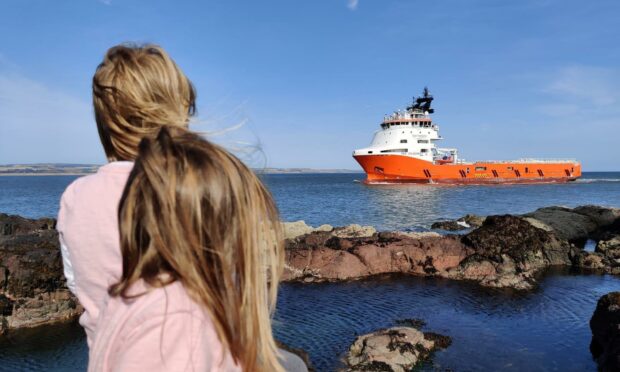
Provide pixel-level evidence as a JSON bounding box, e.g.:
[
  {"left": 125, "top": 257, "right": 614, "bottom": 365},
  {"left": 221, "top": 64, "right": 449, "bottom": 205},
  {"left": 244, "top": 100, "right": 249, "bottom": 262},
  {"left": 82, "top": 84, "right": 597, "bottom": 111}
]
[{"left": 110, "top": 127, "right": 283, "bottom": 371}]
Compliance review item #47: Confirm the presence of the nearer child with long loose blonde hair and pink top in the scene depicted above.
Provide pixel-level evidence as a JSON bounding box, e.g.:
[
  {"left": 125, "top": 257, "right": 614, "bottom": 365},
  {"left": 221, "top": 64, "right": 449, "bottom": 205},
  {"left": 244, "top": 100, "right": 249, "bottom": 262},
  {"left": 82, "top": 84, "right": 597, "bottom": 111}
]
[{"left": 89, "top": 128, "right": 283, "bottom": 371}]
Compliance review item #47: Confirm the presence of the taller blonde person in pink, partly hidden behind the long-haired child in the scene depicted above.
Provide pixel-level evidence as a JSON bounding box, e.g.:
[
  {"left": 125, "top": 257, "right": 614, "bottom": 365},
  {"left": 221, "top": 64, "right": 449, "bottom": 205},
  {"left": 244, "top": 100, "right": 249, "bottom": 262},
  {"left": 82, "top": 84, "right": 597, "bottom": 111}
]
[{"left": 57, "top": 45, "right": 196, "bottom": 346}]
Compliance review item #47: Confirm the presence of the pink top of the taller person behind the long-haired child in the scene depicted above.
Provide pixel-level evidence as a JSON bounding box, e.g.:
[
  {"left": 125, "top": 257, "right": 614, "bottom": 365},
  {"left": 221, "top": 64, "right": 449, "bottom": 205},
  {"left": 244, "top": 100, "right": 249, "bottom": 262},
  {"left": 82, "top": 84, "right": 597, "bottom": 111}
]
[{"left": 56, "top": 162, "right": 133, "bottom": 346}]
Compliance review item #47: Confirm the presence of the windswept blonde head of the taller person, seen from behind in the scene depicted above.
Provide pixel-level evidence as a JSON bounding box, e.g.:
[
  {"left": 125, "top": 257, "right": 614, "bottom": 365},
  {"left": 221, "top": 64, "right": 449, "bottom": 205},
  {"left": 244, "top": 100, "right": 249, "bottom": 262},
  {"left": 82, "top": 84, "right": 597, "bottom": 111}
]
[{"left": 93, "top": 45, "right": 196, "bottom": 160}]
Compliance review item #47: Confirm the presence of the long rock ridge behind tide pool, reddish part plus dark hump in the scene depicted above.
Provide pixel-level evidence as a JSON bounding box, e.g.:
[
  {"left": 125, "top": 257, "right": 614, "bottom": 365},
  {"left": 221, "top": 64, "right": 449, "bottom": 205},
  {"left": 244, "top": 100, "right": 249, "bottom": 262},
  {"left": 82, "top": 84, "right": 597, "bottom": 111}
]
[{"left": 283, "top": 215, "right": 577, "bottom": 289}]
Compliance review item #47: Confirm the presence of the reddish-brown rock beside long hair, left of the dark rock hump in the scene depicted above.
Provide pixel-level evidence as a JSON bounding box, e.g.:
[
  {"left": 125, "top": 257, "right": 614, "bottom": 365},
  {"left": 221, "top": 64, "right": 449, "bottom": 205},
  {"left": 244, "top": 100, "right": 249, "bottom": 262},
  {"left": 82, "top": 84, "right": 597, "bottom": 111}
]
[{"left": 283, "top": 232, "right": 470, "bottom": 282}]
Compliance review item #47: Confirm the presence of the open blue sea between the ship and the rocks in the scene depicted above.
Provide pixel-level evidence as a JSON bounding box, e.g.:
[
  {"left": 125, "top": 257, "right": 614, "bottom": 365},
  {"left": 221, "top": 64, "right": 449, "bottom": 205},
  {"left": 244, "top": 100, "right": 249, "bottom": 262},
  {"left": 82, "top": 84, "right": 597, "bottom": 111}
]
[{"left": 263, "top": 172, "right": 620, "bottom": 230}]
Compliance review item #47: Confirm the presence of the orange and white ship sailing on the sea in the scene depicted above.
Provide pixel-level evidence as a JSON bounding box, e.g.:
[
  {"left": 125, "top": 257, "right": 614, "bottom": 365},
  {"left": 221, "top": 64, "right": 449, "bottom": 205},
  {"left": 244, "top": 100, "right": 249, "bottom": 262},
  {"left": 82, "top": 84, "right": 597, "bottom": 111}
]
[{"left": 353, "top": 88, "right": 581, "bottom": 184}]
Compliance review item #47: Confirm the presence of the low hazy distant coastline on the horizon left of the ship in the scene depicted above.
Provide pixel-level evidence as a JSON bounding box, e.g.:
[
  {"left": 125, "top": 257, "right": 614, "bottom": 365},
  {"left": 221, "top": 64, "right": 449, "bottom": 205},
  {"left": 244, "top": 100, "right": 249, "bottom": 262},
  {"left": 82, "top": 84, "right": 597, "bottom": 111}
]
[{"left": 0, "top": 163, "right": 361, "bottom": 176}]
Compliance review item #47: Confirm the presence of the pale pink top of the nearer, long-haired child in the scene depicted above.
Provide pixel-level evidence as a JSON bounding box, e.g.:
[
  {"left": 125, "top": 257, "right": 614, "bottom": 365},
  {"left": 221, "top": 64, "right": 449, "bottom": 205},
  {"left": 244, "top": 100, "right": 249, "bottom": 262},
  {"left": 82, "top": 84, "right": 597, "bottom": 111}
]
[{"left": 88, "top": 282, "right": 241, "bottom": 372}]
